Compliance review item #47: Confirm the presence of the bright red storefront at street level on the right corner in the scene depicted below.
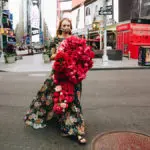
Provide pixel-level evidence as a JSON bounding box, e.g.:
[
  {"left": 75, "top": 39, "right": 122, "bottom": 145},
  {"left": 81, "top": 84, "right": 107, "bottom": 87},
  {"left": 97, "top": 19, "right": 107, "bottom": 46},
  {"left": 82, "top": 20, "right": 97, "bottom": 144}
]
[{"left": 116, "top": 19, "right": 150, "bottom": 59}]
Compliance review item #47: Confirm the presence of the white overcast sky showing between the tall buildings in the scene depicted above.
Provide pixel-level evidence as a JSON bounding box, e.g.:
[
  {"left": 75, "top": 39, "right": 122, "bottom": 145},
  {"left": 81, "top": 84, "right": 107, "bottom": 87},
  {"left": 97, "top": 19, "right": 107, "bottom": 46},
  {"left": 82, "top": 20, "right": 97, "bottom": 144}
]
[{"left": 9, "top": 0, "right": 56, "bottom": 35}]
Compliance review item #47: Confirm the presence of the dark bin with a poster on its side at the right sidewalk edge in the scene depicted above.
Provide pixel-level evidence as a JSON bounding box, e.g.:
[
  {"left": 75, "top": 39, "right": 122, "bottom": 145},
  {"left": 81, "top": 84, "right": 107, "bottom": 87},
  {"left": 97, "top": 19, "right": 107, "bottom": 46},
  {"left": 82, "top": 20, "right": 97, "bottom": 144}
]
[{"left": 138, "top": 46, "right": 150, "bottom": 66}]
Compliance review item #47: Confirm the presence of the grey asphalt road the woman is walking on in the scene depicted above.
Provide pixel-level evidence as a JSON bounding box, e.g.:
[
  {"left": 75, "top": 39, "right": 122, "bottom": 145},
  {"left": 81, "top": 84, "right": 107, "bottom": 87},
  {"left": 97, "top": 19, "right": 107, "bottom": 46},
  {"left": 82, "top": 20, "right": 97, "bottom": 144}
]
[{"left": 0, "top": 70, "right": 150, "bottom": 150}]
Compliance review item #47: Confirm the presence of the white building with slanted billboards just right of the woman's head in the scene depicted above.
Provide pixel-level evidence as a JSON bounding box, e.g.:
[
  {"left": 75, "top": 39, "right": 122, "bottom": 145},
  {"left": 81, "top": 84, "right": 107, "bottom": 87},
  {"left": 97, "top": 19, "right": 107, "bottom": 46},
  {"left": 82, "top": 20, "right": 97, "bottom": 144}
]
[{"left": 72, "top": 0, "right": 117, "bottom": 37}]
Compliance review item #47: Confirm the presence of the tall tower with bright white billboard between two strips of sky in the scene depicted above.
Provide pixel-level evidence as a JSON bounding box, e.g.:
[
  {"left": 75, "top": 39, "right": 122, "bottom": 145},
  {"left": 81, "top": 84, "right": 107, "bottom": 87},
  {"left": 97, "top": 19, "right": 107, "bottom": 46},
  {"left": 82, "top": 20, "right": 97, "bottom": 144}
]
[{"left": 16, "top": 0, "right": 44, "bottom": 45}]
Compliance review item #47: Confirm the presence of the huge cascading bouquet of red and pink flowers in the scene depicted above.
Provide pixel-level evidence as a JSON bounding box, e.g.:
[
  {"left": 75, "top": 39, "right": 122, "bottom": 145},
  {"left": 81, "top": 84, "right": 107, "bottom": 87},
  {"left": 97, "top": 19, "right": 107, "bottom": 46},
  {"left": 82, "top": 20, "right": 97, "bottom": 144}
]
[{"left": 53, "top": 36, "right": 94, "bottom": 114}]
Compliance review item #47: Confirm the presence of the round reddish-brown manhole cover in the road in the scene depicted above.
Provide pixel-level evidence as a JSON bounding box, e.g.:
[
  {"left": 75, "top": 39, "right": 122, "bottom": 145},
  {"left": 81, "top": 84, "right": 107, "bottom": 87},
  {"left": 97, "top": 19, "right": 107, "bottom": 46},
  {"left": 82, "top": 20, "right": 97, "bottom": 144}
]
[{"left": 92, "top": 132, "right": 150, "bottom": 150}]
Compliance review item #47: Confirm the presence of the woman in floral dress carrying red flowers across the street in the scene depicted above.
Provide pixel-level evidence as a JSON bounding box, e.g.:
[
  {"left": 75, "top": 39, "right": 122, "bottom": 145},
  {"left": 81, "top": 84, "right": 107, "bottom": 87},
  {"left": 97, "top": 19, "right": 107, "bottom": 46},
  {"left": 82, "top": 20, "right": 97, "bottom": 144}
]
[{"left": 24, "top": 18, "right": 91, "bottom": 144}]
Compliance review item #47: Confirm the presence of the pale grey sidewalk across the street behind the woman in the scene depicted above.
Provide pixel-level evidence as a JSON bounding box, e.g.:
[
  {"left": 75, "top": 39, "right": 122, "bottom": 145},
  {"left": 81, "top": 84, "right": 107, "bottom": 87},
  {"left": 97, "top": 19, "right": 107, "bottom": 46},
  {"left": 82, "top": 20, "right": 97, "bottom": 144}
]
[{"left": 0, "top": 54, "right": 150, "bottom": 72}]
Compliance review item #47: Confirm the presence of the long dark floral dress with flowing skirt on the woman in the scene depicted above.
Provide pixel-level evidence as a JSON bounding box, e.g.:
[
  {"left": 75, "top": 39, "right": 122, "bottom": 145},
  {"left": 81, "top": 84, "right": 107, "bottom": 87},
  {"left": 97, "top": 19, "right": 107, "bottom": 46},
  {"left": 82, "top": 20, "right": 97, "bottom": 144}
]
[{"left": 24, "top": 38, "right": 85, "bottom": 136}]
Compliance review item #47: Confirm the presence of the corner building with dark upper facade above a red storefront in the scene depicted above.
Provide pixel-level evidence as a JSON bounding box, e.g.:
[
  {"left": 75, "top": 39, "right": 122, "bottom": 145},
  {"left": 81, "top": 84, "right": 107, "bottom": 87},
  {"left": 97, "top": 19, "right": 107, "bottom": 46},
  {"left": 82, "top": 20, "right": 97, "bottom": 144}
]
[{"left": 116, "top": 0, "right": 150, "bottom": 59}]
